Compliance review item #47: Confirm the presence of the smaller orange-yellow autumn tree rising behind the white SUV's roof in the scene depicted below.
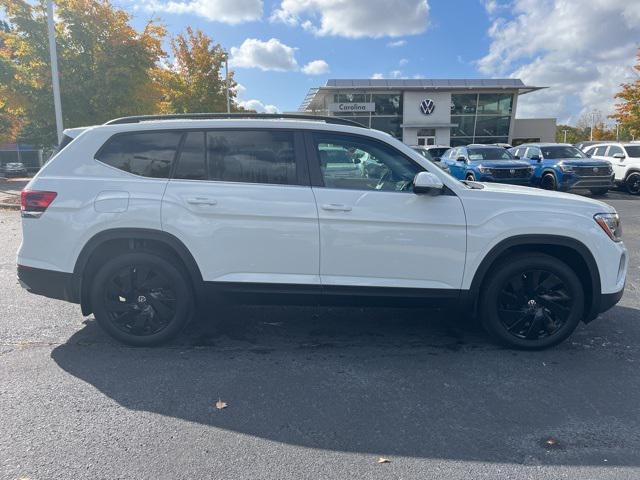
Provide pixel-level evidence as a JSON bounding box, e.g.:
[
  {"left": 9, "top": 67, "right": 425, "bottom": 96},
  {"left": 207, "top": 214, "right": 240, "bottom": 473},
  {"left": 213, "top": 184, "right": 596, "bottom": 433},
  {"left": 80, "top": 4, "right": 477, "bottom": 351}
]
[{"left": 157, "top": 27, "right": 239, "bottom": 113}]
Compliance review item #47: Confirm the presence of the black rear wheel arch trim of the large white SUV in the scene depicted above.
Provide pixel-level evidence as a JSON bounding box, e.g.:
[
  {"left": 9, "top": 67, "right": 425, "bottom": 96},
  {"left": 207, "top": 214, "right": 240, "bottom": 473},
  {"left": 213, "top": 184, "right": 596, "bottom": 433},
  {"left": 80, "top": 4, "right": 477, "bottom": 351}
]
[{"left": 73, "top": 228, "right": 204, "bottom": 315}]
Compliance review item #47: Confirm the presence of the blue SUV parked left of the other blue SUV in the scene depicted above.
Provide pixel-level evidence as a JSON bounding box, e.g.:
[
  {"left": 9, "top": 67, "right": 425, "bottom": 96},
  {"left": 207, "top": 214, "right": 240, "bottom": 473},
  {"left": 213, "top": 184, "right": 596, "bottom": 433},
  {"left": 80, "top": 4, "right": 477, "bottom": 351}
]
[{"left": 441, "top": 145, "right": 534, "bottom": 185}]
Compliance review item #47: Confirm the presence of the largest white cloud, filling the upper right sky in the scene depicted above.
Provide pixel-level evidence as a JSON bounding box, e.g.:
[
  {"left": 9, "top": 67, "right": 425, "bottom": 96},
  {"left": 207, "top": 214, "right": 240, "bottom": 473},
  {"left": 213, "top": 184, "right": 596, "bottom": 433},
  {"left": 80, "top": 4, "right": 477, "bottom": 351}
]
[{"left": 477, "top": 0, "right": 640, "bottom": 122}]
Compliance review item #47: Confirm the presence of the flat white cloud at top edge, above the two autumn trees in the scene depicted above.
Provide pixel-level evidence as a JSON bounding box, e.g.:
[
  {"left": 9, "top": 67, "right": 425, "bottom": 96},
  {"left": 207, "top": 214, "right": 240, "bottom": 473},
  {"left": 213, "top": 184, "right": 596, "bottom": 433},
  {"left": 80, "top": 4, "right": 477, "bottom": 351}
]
[{"left": 135, "top": 0, "right": 263, "bottom": 25}]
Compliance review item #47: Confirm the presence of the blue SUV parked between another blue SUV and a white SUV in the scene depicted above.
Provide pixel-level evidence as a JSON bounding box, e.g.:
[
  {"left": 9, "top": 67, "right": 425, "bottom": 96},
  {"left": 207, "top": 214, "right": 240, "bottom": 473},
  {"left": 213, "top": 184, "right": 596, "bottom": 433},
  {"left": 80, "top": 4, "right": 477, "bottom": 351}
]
[{"left": 509, "top": 143, "right": 614, "bottom": 195}]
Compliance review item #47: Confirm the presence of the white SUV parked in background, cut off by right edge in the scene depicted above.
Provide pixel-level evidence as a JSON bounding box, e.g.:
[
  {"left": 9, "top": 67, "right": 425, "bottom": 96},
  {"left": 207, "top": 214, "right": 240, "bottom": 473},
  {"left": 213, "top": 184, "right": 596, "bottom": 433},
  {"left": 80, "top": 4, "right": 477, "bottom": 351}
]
[{"left": 584, "top": 142, "right": 640, "bottom": 195}]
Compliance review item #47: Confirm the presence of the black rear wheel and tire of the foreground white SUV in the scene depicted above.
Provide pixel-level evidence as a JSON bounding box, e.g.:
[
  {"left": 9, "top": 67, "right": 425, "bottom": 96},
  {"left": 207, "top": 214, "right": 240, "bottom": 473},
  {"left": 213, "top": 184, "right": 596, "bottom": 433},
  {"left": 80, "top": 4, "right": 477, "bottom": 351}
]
[{"left": 91, "top": 252, "right": 194, "bottom": 347}]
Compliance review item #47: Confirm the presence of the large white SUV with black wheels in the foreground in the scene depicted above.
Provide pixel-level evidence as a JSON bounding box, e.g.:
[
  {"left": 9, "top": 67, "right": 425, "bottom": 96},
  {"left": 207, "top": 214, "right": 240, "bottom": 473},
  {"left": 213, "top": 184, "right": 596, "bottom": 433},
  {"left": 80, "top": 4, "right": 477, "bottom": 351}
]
[{"left": 18, "top": 115, "right": 628, "bottom": 348}]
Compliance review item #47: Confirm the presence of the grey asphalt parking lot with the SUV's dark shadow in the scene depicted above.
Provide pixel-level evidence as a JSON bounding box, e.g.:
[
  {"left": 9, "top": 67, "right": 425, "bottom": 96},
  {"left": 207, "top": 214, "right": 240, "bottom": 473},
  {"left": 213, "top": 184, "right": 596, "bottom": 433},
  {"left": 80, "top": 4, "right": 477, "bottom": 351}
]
[{"left": 0, "top": 192, "right": 640, "bottom": 480}]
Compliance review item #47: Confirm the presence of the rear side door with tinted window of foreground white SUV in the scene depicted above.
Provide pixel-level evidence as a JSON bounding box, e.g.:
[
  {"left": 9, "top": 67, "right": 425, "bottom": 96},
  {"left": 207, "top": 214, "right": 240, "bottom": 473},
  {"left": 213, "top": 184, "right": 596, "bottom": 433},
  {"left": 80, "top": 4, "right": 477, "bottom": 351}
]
[{"left": 162, "top": 129, "right": 320, "bottom": 285}]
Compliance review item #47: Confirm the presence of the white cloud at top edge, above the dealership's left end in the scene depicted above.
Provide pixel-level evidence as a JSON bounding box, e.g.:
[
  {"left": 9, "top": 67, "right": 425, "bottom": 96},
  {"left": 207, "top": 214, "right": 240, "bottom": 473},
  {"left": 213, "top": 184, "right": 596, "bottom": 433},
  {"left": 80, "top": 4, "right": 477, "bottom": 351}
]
[{"left": 270, "top": 0, "right": 429, "bottom": 38}]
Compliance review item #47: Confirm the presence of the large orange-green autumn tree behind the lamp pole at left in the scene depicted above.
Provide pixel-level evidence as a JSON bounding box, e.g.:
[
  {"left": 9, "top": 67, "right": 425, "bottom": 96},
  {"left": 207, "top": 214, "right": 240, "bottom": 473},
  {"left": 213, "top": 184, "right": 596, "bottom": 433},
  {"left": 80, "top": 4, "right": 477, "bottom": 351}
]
[{"left": 0, "top": 0, "right": 166, "bottom": 146}]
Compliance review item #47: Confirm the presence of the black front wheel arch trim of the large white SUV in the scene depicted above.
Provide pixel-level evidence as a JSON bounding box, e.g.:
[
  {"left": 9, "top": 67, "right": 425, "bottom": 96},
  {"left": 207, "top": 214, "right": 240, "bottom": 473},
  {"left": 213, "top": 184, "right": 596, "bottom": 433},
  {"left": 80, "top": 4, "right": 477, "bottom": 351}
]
[{"left": 469, "top": 234, "right": 601, "bottom": 322}]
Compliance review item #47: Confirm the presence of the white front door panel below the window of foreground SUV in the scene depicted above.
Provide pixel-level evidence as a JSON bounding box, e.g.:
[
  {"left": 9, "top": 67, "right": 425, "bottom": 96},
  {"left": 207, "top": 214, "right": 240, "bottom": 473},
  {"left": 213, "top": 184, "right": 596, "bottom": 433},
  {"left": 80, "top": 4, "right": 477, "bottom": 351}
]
[{"left": 314, "top": 188, "right": 466, "bottom": 289}]
